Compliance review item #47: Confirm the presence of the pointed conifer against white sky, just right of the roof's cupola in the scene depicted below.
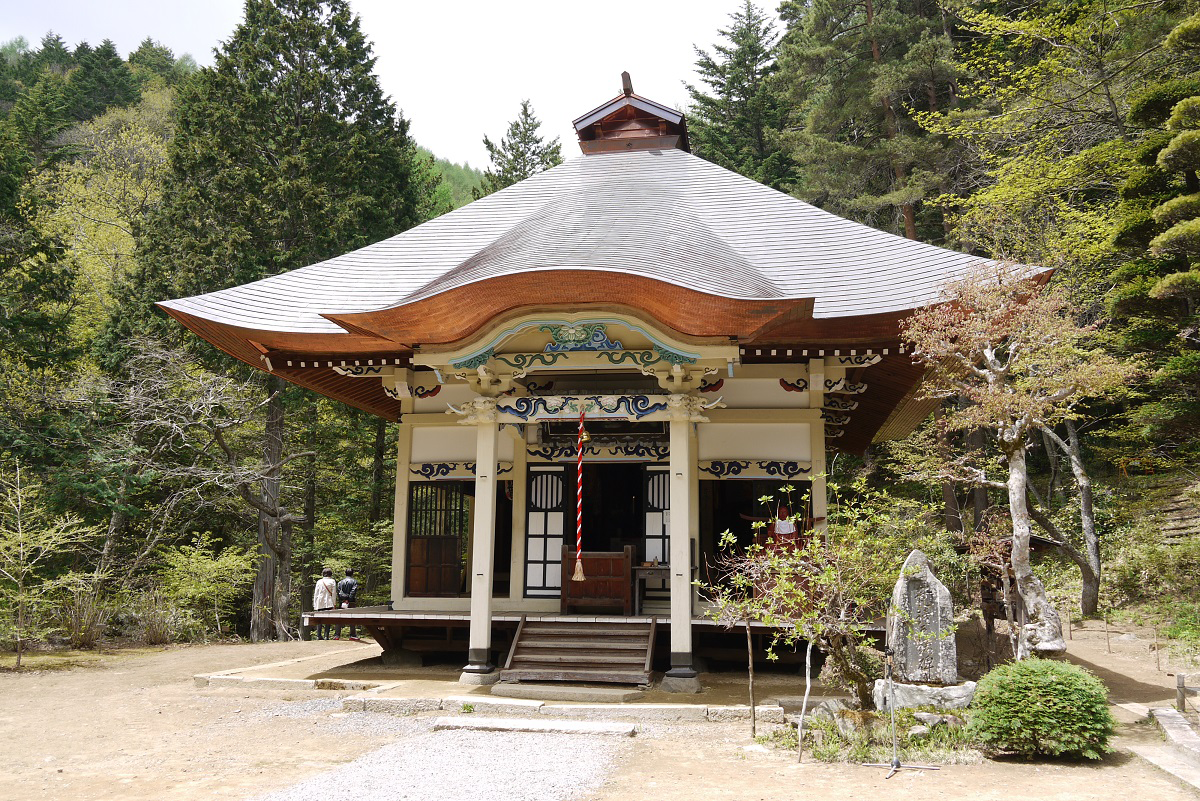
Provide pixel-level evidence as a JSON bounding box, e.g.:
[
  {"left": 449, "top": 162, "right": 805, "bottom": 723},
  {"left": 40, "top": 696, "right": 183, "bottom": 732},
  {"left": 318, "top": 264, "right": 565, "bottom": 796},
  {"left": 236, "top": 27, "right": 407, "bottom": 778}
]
[{"left": 686, "top": 0, "right": 793, "bottom": 189}]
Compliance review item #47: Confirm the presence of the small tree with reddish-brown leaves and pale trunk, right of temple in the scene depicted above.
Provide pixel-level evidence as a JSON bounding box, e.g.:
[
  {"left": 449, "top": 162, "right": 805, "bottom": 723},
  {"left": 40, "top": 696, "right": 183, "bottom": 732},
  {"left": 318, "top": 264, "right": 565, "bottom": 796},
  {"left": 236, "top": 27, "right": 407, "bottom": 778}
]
[{"left": 902, "top": 269, "right": 1132, "bottom": 658}]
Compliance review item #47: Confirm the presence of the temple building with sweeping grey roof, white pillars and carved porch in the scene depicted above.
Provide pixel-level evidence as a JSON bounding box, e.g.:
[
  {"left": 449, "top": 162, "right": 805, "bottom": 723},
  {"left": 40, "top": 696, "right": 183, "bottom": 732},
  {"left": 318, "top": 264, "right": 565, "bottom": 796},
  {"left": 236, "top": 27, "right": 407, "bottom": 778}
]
[{"left": 160, "top": 78, "right": 979, "bottom": 683}]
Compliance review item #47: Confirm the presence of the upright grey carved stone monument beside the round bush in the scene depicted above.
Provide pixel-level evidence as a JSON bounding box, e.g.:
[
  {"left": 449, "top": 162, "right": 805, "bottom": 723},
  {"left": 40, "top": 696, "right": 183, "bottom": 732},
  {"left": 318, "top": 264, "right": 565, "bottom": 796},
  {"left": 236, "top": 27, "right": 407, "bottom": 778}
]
[{"left": 887, "top": 550, "right": 959, "bottom": 685}]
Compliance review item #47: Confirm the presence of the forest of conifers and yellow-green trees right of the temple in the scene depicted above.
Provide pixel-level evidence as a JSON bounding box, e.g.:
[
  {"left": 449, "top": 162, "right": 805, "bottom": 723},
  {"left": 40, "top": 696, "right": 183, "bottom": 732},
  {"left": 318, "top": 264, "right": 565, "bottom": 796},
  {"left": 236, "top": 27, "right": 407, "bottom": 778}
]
[{"left": 689, "top": 0, "right": 1200, "bottom": 628}]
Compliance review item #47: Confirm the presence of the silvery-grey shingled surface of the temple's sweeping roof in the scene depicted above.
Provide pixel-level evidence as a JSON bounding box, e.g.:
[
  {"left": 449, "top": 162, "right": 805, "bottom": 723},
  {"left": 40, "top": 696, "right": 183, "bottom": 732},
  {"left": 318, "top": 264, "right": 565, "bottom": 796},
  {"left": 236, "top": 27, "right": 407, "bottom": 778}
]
[{"left": 161, "top": 150, "right": 980, "bottom": 333}]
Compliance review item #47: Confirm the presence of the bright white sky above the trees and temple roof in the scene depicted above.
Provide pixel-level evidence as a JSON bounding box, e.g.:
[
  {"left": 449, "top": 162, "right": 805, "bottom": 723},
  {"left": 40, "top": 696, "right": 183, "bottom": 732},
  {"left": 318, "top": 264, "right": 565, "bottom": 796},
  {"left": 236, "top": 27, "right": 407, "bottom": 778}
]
[{"left": 0, "top": 0, "right": 773, "bottom": 168}]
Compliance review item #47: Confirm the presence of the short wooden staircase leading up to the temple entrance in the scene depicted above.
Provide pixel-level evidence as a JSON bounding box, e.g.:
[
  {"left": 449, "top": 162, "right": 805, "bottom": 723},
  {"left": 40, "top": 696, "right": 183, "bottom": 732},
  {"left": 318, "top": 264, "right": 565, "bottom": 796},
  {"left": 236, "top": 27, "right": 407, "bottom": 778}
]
[{"left": 500, "top": 618, "right": 656, "bottom": 686}]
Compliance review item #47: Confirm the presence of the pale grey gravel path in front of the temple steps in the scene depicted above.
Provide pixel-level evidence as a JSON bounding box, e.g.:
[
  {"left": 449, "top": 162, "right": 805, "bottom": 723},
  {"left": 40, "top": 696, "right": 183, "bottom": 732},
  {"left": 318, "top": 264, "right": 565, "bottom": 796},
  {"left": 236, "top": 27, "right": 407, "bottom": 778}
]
[{"left": 249, "top": 718, "right": 631, "bottom": 801}]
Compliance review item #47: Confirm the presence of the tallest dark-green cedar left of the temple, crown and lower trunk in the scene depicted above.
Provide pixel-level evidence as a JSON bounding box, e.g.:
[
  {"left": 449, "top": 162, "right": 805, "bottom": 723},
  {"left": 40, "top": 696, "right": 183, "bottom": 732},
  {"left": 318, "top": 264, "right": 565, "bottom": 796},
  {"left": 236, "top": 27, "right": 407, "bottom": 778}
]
[{"left": 120, "top": 0, "right": 436, "bottom": 640}]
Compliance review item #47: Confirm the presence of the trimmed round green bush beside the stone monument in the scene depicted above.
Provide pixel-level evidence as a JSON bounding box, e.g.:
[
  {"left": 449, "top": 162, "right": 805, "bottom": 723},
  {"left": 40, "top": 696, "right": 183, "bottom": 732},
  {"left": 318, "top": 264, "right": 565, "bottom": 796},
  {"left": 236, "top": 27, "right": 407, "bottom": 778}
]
[{"left": 970, "top": 660, "right": 1116, "bottom": 759}]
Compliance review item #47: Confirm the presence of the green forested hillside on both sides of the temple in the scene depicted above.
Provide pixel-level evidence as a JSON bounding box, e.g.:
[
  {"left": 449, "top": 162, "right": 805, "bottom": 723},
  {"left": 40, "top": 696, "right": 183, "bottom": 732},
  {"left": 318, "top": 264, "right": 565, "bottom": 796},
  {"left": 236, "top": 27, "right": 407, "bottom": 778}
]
[{"left": 0, "top": 0, "right": 1200, "bottom": 645}]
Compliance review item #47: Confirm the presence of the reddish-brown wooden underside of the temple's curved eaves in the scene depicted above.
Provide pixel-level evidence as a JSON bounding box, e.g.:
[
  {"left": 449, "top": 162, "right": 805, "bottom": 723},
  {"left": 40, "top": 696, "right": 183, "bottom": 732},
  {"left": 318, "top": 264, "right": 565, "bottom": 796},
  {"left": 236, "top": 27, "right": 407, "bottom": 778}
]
[{"left": 163, "top": 287, "right": 923, "bottom": 453}]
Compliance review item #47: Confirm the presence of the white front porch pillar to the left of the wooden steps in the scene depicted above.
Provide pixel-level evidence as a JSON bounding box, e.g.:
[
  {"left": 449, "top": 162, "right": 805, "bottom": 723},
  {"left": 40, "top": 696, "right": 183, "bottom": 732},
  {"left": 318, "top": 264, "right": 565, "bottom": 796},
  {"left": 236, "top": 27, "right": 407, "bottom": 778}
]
[{"left": 463, "top": 411, "right": 498, "bottom": 673}]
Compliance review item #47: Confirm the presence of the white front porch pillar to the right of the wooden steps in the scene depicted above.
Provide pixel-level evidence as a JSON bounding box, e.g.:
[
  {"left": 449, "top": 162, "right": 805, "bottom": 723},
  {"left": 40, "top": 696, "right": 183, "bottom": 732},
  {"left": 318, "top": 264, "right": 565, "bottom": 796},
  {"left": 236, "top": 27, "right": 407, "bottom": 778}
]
[{"left": 667, "top": 412, "right": 696, "bottom": 679}]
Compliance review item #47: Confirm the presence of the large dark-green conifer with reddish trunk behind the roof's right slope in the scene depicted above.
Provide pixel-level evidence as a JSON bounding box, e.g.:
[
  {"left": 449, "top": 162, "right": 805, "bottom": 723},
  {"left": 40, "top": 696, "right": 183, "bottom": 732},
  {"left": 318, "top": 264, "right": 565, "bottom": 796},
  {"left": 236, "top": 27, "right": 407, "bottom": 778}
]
[{"left": 780, "top": 0, "right": 958, "bottom": 241}]
